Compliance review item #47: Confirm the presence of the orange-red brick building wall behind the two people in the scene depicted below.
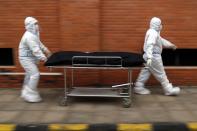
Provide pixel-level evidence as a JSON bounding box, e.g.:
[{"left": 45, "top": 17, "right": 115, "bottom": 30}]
[{"left": 0, "top": 0, "right": 197, "bottom": 87}]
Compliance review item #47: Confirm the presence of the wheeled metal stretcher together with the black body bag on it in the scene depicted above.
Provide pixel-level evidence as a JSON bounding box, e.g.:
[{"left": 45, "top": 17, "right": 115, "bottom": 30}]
[{"left": 45, "top": 51, "right": 144, "bottom": 107}]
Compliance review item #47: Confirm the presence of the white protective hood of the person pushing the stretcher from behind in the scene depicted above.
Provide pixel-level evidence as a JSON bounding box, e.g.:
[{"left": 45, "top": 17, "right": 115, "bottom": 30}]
[{"left": 24, "top": 17, "right": 39, "bottom": 37}]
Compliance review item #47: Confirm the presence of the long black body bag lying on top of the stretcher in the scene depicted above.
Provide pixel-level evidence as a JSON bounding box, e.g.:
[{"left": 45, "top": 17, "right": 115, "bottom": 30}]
[{"left": 44, "top": 51, "right": 144, "bottom": 67}]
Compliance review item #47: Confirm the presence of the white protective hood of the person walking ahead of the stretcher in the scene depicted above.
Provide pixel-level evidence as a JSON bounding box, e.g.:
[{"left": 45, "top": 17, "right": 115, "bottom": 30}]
[{"left": 150, "top": 17, "right": 162, "bottom": 32}]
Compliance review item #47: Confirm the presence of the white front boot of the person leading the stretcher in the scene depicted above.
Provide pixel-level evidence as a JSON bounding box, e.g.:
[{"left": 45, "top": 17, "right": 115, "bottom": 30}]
[{"left": 163, "top": 84, "right": 180, "bottom": 96}]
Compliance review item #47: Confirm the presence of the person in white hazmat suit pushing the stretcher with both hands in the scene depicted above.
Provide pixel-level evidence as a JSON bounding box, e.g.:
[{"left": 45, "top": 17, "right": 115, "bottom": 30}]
[{"left": 19, "top": 17, "right": 51, "bottom": 102}]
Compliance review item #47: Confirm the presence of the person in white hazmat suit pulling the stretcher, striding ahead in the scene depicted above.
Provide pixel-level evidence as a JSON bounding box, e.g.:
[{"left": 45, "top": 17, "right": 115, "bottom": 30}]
[{"left": 134, "top": 17, "right": 180, "bottom": 95}]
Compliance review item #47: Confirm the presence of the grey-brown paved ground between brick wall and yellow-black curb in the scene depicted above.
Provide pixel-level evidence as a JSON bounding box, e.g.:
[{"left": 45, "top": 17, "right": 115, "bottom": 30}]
[{"left": 0, "top": 87, "right": 197, "bottom": 124}]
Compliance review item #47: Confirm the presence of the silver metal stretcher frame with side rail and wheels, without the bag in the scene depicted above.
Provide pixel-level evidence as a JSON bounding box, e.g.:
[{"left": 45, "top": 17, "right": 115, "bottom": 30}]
[{"left": 48, "top": 56, "right": 141, "bottom": 107}]
